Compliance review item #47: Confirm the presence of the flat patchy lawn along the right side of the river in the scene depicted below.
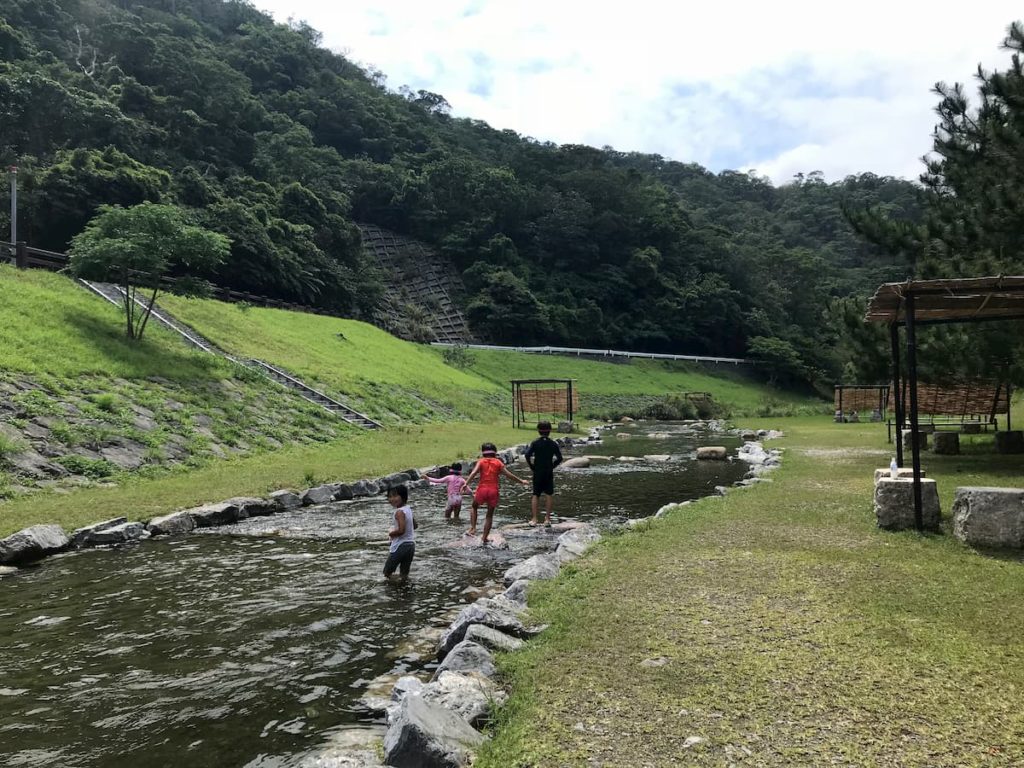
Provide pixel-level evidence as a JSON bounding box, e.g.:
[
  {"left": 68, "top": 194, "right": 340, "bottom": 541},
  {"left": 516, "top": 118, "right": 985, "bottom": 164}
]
[{"left": 477, "top": 419, "right": 1024, "bottom": 768}]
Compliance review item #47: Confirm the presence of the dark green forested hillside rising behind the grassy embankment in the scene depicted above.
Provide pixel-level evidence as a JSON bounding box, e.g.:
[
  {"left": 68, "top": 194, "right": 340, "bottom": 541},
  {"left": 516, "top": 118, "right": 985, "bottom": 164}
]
[{"left": 0, "top": 0, "right": 920, "bottom": 380}]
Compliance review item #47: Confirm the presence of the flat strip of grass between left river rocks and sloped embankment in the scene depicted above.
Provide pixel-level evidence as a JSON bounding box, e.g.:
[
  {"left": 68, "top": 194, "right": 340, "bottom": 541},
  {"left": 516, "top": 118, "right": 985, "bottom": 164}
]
[{"left": 0, "top": 417, "right": 531, "bottom": 537}]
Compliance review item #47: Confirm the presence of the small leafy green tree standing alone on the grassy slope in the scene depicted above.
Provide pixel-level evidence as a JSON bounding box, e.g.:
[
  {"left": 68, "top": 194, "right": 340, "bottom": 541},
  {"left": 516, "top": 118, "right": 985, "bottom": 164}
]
[{"left": 70, "top": 203, "right": 230, "bottom": 339}]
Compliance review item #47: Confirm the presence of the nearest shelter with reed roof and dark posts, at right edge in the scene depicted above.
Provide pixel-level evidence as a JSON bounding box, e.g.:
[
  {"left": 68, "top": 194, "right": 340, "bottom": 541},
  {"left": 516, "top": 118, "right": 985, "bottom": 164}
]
[{"left": 864, "top": 275, "right": 1024, "bottom": 530}]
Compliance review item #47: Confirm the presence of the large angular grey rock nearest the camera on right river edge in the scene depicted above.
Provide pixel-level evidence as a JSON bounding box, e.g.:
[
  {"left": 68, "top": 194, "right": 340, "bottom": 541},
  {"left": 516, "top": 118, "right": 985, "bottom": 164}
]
[{"left": 384, "top": 696, "right": 484, "bottom": 768}]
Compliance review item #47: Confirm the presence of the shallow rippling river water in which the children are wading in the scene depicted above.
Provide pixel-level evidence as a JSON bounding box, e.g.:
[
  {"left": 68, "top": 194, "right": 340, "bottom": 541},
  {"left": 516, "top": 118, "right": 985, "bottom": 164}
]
[{"left": 0, "top": 424, "right": 745, "bottom": 768}]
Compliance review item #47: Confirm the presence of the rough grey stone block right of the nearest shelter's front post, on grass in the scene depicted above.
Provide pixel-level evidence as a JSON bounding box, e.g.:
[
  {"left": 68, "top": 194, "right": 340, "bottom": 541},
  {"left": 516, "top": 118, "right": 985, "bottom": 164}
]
[{"left": 952, "top": 485, "right": 1024, "bottom": 549}]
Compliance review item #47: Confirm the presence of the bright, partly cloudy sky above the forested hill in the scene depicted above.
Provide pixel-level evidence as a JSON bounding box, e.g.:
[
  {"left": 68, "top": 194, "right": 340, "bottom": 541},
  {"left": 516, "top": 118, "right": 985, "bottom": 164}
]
[{"left": 254, "top": 0, "right": 1024, "bottom": 184}]
